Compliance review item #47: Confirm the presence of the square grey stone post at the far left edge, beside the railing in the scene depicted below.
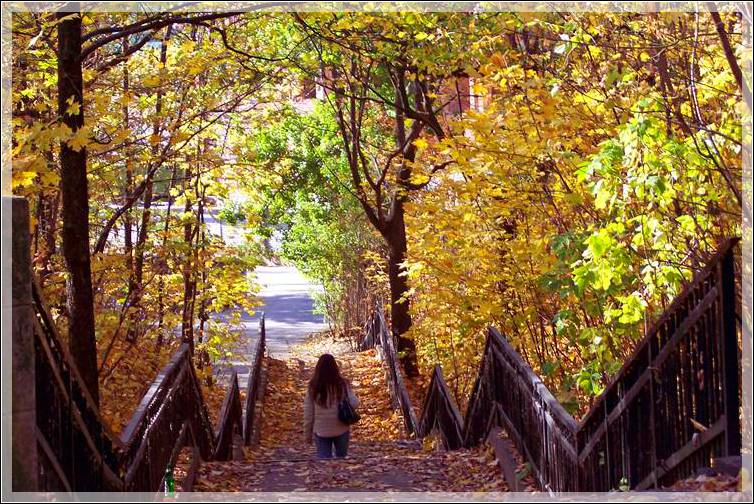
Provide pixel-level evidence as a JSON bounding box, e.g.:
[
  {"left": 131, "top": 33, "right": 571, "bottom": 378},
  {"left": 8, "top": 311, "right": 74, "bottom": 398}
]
[{"left": 2, "top": 196, "right": 39, "bottom": 492}]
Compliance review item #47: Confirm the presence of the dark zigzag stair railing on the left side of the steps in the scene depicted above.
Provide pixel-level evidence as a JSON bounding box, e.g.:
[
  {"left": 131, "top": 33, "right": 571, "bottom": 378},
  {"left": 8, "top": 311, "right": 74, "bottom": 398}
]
[{"left": 32, "top": 276, "right": 266, "bottom": 492}]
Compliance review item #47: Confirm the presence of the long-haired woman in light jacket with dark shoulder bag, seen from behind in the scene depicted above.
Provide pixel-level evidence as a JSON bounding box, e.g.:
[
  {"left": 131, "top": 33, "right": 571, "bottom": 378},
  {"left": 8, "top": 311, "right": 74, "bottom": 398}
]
[{"left": 304, "top": 354, "right": 359, "bottom": 459}]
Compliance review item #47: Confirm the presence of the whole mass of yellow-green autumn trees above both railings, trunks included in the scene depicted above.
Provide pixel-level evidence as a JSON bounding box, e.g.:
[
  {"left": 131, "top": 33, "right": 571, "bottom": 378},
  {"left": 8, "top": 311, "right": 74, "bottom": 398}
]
[{"left": 12, "top": 10, "right": 751, "bottom": 409}]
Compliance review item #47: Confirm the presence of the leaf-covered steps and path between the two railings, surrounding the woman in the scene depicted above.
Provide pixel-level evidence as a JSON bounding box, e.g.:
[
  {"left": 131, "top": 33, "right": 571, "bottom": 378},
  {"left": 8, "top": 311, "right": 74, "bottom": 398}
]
[{"left": 194, "top": 336, "right": 507, "bottom": 492}]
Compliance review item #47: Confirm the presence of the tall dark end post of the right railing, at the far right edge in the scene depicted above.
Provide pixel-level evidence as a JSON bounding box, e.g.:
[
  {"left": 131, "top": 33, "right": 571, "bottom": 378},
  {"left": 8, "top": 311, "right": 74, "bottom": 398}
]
[{"left": 719, "top": 246, "right": 741, "bottom": 456}]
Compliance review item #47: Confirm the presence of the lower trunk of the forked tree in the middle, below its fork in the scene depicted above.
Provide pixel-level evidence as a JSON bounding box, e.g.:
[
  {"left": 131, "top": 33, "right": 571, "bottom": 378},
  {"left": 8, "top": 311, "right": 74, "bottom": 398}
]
[{"left": 383, "top": 201, "right": 419, "bottom": 376}]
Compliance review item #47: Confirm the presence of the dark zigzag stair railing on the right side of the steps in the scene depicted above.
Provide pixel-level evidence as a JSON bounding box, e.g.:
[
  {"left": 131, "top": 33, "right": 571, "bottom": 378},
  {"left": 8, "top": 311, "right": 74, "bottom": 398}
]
[{"left": 368, "top": 238, "right": 741, "bottom": 492}]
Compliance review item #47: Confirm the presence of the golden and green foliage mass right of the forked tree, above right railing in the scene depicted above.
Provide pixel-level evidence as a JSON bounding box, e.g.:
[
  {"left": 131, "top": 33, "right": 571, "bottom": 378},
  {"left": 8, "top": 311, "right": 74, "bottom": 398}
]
[{"left": 400, "top": 9, "right": 740, "bottom": 410}]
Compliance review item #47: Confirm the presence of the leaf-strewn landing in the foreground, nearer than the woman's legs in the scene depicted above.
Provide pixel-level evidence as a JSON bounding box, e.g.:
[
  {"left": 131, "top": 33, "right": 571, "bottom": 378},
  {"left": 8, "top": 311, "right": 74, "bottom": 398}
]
[{"left": 195, "top": 442, "right": 508, "bottom": 492}]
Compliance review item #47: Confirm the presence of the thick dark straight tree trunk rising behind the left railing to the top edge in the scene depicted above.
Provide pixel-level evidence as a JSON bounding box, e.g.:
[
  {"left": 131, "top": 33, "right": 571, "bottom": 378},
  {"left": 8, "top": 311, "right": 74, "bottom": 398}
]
[{"left": 57, "top": 12, "right": 99, "bottom": 404}]
